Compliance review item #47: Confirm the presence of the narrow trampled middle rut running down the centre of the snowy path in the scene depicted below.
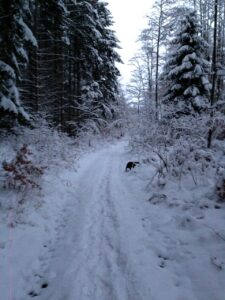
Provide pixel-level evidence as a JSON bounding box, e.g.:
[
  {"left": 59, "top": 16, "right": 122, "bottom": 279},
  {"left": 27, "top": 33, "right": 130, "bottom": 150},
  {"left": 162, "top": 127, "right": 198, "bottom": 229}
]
[{"left": 95, "top": 161, "right": 127, "bottom": 300}]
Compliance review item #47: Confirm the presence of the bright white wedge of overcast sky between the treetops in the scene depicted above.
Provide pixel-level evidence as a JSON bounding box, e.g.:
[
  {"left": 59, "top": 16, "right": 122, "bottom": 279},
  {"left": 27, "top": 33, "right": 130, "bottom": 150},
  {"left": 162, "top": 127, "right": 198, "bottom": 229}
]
[{"left": 106, "top": 0, "right": 154, "bottom": 82}]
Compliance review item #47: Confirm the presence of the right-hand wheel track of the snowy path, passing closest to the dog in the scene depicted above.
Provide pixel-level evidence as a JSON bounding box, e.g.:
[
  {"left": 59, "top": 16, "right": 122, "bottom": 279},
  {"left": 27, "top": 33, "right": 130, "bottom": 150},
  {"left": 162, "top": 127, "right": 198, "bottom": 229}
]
[{"left": 107, "top": 148, "right": 153, "bottom": 300}]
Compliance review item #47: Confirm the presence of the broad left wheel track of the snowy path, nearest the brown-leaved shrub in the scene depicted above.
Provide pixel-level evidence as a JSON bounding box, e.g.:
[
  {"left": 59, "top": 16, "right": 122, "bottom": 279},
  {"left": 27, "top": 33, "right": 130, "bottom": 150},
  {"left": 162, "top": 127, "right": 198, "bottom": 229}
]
[{"left": 35, "top": 156, "right": 111, "bottom": 300}]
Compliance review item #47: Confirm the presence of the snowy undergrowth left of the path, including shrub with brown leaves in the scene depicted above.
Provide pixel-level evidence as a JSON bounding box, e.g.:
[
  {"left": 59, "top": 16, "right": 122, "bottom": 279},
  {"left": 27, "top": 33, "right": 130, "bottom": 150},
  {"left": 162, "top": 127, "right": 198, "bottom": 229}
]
[{"left": 0, "top": 119, "right": 80, "bottom": 221}]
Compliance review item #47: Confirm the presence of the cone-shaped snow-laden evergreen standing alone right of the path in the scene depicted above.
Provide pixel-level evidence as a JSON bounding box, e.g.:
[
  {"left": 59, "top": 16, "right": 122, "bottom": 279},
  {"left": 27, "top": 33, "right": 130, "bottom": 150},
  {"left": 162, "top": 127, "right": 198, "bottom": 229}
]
[{"left": 163, "top": 11, "right": 210, "bottom": 113}]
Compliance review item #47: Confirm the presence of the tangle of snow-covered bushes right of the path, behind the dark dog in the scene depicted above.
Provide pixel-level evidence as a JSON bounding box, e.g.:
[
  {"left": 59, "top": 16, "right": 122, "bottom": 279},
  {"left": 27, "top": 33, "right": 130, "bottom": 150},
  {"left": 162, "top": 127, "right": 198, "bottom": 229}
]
[{"left": 130, "top": 113, "right": 225, "bottom": 198}]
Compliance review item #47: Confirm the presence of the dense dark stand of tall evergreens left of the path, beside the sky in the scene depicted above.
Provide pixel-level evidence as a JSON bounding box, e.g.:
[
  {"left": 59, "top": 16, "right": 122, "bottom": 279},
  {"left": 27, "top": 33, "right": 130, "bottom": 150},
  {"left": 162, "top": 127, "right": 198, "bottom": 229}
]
[{"left": 6, "top": 0, "right": 120, "bottom": 134}]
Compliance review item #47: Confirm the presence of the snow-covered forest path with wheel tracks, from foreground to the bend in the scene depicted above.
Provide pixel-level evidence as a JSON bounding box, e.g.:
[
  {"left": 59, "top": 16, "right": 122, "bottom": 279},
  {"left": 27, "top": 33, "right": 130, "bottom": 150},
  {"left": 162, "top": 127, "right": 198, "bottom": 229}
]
[{"left": 37, "top": 144, "right": 153, "bottom": 300}]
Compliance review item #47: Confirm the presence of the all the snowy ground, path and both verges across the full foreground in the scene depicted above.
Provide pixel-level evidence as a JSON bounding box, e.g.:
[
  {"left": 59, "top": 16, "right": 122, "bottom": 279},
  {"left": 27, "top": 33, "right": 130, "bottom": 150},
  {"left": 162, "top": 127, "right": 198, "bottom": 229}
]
[{"left": 0, "top": 142, "right": 225, "bottom": 300}]
